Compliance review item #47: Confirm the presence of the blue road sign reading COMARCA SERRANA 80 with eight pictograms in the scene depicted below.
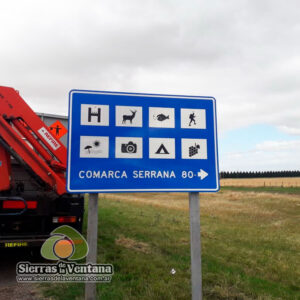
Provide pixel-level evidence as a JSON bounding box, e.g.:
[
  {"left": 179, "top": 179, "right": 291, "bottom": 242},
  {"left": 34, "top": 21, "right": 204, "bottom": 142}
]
[{"left": 67, "top": 90, "right": 219, "bottom": 193}]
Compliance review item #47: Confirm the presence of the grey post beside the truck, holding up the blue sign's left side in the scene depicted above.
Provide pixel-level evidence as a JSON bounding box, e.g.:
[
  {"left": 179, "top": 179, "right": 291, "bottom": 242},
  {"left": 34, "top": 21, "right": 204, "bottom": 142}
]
[{"left": 85, "top": 194, "right": 98, "bottom": 300}]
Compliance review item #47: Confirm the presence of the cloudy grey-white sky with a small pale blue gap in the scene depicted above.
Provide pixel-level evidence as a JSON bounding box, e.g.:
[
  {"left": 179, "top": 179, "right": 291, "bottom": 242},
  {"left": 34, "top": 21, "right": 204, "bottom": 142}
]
[{"left": 0, "top": 0, "right": 300, "bottom": 170}]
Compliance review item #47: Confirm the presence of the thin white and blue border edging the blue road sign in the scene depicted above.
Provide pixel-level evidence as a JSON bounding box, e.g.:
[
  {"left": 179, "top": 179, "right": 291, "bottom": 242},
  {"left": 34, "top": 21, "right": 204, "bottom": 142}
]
[{"left": 67, "top": 89, "right": 220, "bottom": 193}]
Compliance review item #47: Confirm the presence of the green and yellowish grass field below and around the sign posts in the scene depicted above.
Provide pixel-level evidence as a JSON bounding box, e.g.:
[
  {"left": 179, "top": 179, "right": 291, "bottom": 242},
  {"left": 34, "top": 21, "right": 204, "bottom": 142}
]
[{"left": 43, "top": 187, "right": 300, "bottom": 300}]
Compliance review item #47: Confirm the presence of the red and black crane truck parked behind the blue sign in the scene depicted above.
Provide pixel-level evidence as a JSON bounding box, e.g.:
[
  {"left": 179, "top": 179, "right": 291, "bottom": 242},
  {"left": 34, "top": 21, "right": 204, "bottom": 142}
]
[{"left": 0, "top": 86, "right": 84, "bottom": 248}]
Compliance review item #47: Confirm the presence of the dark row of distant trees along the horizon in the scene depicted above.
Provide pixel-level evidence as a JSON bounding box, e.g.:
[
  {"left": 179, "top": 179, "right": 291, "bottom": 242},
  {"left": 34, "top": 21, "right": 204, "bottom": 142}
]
[{"left": 220, "top": 171, "right": 300, "bottom": 178}]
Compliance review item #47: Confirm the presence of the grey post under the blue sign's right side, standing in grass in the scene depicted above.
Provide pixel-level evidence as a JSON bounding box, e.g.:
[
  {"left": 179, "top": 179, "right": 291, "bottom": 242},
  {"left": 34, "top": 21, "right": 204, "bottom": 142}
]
[{"left": 189, "top": 192, "right": 202, "bottom": 300}]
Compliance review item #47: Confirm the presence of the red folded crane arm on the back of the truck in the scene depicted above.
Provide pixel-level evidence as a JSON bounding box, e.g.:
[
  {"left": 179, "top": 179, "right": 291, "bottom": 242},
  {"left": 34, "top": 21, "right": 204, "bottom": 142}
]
[{"left": 0, "top": 86, "right": 67, "bottom": 195}]
